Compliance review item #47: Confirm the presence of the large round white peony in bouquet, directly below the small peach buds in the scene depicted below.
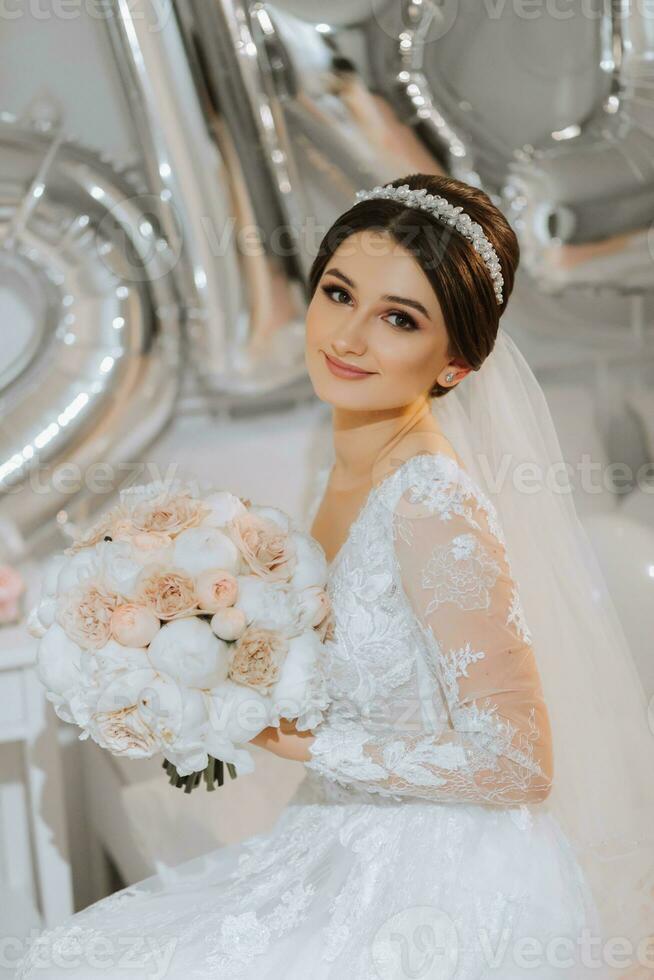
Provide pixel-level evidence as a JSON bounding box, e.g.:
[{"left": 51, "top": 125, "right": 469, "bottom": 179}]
[{"left": 148, "top": 616, "right": 229, "bottom": 687}]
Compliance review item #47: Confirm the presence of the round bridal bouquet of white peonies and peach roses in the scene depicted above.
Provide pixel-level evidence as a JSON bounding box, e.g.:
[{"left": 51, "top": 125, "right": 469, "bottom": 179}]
[{"left": 28, "top": 481, "right": 333, "bottom": 792}]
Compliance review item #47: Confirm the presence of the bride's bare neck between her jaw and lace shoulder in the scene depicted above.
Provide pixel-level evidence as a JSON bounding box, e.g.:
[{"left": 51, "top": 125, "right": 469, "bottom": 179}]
[{"left": 332, "top": 398, "right": 440, "bottom": 490}]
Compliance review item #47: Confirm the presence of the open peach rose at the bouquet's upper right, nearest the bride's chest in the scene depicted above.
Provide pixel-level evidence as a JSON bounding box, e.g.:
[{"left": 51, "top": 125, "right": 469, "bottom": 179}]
[{"left": 225, "top": 512, "right": 296, "bottom": 582}]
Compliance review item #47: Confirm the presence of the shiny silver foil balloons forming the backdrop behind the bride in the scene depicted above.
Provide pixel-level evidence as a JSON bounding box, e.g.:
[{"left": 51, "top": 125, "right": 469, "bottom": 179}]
[{"left": 0, "top": 0, "right": 654, "bottom": 551}]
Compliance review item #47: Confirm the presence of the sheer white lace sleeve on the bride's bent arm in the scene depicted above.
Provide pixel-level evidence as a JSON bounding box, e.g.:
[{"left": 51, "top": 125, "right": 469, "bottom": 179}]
[{"left": 307, "top": 461, "right": 552, "bottom": 806}]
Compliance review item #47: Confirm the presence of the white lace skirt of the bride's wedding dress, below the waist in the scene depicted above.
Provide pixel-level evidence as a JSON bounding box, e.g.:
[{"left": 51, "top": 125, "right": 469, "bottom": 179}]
[{"left": 16, "top": 770, "right": 612, "bottom": 980}]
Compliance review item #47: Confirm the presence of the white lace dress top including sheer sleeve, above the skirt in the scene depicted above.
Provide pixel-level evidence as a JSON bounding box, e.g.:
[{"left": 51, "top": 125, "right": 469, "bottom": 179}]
[{"left": 294, "top": 452, "right": 550, "bottom": 806}]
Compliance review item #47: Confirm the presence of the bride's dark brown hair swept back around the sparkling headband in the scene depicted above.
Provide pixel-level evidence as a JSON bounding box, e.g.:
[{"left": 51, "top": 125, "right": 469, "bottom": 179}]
[{"left": 309, "top": 174, "right": 520, "bottom": 398}]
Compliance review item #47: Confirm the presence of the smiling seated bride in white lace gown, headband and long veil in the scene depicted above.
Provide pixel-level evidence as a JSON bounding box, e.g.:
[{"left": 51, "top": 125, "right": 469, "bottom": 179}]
[{"left": 16, "top": 174, "right": 654, "bottom": 980}]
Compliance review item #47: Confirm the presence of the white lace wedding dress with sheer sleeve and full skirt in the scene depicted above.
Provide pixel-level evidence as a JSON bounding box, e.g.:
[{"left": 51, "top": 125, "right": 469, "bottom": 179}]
[{"left": 16, "top": 453, "right": 607, "bottom": 980}]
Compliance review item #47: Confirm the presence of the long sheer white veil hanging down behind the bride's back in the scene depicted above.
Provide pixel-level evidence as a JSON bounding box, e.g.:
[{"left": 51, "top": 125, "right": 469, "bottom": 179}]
[{"left": 432, "top": 327, "right": 654, "bottom": 976}]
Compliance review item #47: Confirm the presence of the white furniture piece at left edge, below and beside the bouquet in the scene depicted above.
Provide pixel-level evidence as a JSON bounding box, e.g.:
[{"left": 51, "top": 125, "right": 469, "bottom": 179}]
[{"left": 0, "top": 569, "right": 73, "bottom": 929}]
